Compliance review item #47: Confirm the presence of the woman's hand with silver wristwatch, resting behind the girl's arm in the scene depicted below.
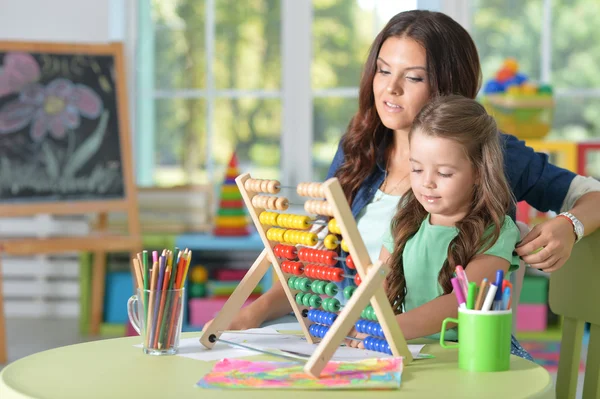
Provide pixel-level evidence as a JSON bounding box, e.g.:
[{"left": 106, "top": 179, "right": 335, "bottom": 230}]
[{"left": 516, "top": 217, "right": 575, "bottom": 273}]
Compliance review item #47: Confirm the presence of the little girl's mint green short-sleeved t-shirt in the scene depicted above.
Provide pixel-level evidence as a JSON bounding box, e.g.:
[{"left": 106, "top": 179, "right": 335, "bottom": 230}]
[{"left": 383, "top": 215, "right": 520, "bottom": 340}]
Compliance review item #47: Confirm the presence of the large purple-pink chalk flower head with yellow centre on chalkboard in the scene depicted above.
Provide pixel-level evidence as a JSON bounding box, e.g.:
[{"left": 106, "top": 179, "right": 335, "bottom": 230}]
[{"left": 0, "top": 78, "right": 103, "bottom": 141}]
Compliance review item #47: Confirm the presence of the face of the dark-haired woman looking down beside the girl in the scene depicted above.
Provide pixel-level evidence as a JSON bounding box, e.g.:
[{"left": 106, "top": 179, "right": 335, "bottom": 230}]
[{"left": 373, "top": 37, "right": 431, "bottom": 131}]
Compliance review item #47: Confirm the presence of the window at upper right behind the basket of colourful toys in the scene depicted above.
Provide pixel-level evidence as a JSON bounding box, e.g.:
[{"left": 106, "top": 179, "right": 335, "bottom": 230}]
[{"left": 471, "top": 0, "right": 600, "bottom": 141}]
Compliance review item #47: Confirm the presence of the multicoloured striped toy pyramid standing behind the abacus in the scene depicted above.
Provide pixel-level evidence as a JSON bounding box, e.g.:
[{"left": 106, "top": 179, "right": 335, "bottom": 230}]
[{"left": 213, "top": 152, "right": 250, "bottom": 237}]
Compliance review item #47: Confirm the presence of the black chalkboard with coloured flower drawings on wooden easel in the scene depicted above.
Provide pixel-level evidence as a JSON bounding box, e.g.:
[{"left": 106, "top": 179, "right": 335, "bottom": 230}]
[{"left": 0, "top": 43, "right": 128, "bottom": 205}]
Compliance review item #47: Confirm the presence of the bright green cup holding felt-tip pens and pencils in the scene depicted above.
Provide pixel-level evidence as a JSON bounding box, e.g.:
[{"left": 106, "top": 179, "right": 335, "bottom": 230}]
[{"left": 440, "top": 308, "right": 512, "bottom": 371}]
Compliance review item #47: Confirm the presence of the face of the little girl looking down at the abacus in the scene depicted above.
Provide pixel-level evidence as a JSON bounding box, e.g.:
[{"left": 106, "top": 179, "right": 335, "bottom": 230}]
[{"left": 410, "top": 130, "right": 476, "bottom": 226}]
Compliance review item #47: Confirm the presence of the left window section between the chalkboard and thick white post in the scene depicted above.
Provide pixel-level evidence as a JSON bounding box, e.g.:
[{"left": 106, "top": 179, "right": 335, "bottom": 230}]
[{"left": 144, "top": 0, "right": 281, "bottom": 186}]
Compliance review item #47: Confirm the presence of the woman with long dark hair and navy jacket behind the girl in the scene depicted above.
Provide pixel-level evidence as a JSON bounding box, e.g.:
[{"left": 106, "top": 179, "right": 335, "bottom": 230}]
[{"left": 206, "top": 10, "right": 600, "bottom": 346}]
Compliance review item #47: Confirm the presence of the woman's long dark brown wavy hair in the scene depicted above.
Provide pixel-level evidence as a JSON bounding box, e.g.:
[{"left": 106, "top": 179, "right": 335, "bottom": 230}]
[{"left": 335, "top": 10, "right": 481, "bottom": 204}]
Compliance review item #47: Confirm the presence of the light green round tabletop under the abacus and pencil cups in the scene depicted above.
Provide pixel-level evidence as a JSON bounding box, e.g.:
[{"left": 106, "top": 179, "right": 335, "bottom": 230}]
[{"left": 0, "top": 333, "right": 554, "bottom": 399}]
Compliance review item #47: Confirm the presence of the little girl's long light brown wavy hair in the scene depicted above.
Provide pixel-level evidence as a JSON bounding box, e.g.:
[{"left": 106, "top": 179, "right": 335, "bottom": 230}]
[{"left": 387, "top": 95, "right": 513, "bottom": 313}]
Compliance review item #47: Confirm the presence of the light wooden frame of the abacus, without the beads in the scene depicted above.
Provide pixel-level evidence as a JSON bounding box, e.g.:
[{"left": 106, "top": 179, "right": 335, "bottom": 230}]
[{"left": 200, "top": 173, "right": 413, "bottom": 377}]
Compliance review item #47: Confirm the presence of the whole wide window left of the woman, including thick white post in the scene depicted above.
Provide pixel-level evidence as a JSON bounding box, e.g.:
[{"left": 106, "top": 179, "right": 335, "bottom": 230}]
[{"left": 141, "top": 0, "right": 417, "bottom": 186}]
